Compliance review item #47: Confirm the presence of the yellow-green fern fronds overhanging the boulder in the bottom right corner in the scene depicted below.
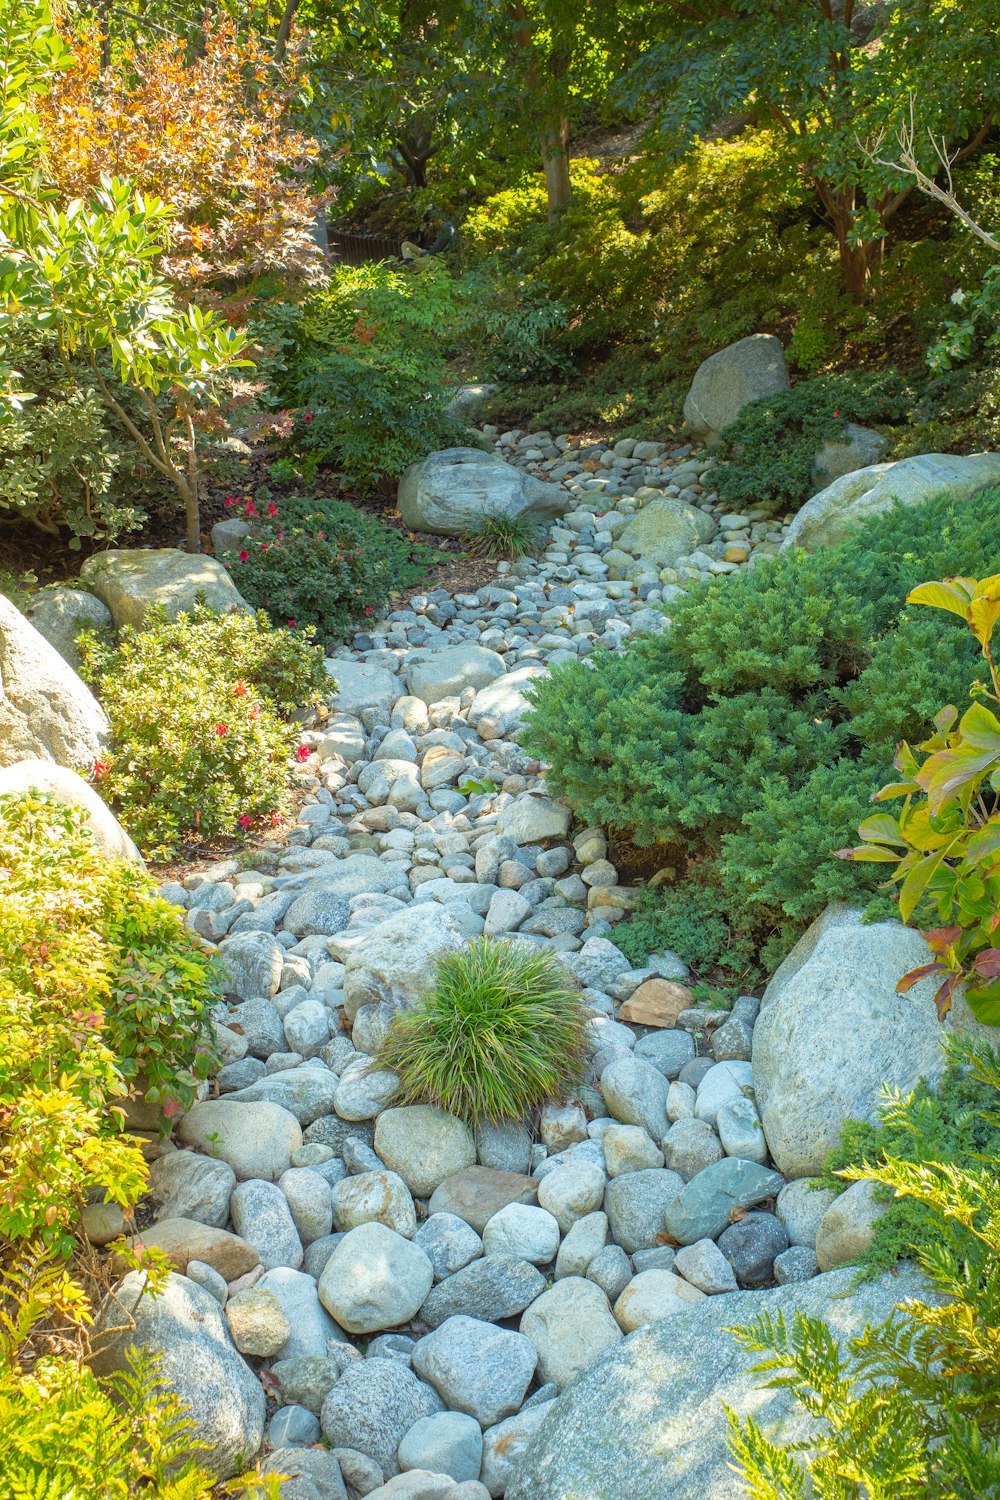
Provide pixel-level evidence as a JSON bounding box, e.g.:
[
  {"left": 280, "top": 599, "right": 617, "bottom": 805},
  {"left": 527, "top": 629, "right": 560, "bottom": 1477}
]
[{"left": 729, "top": 1049, "right": 1000, "bottom": 1500}]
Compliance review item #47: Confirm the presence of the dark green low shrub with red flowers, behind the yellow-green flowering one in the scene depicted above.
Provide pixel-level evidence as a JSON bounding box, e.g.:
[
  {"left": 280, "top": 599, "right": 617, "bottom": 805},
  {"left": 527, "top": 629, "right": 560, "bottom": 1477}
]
[{"left": 226, "top": 498, "right": 438, "bottom": 639}]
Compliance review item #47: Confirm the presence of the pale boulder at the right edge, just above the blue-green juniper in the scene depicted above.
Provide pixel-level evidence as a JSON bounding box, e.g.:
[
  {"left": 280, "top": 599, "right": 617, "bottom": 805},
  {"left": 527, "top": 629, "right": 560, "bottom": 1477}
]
[{"left": 783, "top": 453, "right": 1000, "bottom": 552}]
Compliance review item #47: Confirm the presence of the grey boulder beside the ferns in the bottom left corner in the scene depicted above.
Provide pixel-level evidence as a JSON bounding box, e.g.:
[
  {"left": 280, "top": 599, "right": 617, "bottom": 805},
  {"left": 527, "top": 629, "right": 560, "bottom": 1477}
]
[{"left": 93, "top": 1271, "right": 265, "bottom": 1479}]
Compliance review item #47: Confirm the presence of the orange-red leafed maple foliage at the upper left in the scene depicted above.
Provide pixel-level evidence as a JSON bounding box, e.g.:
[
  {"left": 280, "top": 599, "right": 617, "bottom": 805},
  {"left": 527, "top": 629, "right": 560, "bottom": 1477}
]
[{"left": 39, "top": 23, "right": 322, "bottom": 291}]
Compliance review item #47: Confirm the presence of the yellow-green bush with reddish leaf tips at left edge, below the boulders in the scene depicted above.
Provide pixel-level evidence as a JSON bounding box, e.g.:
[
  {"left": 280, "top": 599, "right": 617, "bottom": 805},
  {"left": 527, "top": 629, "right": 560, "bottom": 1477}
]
[{"left": 0, "top": 795, "right": 220, "bottom": 1254}]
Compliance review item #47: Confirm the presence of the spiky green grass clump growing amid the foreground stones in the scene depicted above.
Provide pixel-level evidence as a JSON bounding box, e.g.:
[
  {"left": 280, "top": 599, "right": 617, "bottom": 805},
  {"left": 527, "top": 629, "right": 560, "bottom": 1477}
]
[{"left": 378, "top": 938, "right": 585, "bottom": 1124}]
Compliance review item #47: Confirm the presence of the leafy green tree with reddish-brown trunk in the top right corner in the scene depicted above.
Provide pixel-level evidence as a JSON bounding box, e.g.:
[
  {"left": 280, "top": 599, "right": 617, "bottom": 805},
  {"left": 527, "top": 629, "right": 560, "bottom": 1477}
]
[{"left": 627, "top": 0, "right": 1000, "bottom": 299}]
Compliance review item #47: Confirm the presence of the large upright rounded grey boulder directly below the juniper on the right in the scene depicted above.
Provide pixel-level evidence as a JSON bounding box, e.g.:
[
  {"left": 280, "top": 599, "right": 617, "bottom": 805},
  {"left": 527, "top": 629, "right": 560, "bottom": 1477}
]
[{"left": 753, "top": 905, "right": 988, "bottom": 1178}]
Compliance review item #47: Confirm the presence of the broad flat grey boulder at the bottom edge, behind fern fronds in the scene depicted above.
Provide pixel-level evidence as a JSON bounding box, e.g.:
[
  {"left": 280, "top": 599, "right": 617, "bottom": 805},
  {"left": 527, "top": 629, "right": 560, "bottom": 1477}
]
[{"left": 507, "top": 1268, "right": 922, "bottom": 1500}]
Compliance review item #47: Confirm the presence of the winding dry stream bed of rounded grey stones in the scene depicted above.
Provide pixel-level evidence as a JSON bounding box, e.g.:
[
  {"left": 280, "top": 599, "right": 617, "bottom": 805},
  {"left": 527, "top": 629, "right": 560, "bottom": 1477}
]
[{"left": 108, "top": 434, "right": 829, "bottom": 1500}]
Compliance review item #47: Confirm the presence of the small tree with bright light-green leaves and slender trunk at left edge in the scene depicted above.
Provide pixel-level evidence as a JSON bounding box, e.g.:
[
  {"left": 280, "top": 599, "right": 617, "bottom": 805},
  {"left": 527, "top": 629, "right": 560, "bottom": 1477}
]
[{"left": 0, "top": 0, "right": 246, "bottom": 552}]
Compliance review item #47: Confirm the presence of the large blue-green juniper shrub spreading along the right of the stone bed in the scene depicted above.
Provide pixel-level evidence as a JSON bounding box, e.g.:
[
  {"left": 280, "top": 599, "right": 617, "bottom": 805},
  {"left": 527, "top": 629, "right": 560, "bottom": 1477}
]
[{"left": 523, "top": 491, "right": 1000, "bottom": 972}]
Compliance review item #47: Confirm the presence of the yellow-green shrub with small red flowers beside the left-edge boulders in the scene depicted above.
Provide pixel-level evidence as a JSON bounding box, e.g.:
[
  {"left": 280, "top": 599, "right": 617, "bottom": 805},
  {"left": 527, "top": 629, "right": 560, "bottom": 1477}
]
[{"left": 79, "top": 609, "right": 328, "bottom": 858}]
